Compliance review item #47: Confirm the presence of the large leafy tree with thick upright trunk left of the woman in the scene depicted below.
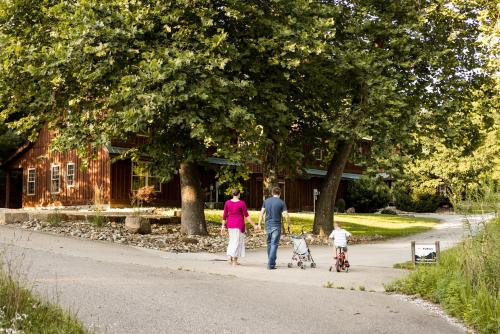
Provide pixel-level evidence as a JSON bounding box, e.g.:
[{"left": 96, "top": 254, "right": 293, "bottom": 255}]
[{"left": 0, "top": 0, "right": 251, "bottom": 234}]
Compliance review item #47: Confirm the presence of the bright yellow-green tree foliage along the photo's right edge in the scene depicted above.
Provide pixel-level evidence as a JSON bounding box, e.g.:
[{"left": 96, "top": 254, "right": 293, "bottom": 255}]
[{"left": 394, "top": 1, "right": 500, "bottom": 205}]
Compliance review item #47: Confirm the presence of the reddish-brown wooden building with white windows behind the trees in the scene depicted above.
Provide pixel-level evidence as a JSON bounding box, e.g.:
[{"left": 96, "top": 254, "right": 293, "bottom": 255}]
[{"left": 0, "top": 127, "right": 362, "bottom": 211}]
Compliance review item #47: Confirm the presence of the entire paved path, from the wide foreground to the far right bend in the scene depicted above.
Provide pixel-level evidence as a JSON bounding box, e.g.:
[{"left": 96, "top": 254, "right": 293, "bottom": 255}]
[{"left": 0, "top": 216, "right": 488, "bottom": 333}]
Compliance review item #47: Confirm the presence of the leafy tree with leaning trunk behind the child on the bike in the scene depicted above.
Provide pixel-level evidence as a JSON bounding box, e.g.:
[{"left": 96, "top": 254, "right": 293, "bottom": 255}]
[{"left": 314, "top": 1, "right": 489, "bottom": 234}]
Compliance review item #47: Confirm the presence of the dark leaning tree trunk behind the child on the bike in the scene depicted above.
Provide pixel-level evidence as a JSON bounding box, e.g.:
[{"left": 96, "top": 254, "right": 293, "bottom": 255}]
[{"left": 313, "top": 140, "right": 353, "bottom": 236}]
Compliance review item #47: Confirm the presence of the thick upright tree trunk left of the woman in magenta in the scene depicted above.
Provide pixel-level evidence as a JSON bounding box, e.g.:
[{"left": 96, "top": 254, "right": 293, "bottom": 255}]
[{"left": 179, "top": 163, "right": 208, "bottom": 235}]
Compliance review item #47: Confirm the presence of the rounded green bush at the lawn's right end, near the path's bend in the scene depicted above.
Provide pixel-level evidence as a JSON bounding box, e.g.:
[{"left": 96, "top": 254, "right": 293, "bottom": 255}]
[{"left": 393, "top": 181, "right": 444, "bottom": 212}]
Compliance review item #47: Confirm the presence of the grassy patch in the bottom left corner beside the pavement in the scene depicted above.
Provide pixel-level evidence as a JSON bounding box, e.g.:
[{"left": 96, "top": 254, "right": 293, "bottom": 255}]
[{"left": 0, "top": 266, "right": 87, "bottom": 334}]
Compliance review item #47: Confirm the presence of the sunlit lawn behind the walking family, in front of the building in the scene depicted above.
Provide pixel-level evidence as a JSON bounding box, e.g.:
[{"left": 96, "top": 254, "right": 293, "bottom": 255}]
[{"left": 205, "top": 210, "right": 439, "bottom": 238}]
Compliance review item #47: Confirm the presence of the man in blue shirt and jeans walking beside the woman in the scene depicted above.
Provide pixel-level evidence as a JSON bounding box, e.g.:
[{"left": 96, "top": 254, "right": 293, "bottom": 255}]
[{"left": 258, "top": 187, "right": 290, "bottom": 269}]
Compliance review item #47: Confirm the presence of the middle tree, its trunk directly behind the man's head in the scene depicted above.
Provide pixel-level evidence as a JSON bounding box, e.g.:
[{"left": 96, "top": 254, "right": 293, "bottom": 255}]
[{"left": 216, "top": 0, "right": 334, "bottom": 197}]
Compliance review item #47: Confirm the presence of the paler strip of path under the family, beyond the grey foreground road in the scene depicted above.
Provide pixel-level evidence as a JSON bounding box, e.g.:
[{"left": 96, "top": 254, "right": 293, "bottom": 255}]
[{"left": 131, "top": 214, "right": 490, "bottom": 292}]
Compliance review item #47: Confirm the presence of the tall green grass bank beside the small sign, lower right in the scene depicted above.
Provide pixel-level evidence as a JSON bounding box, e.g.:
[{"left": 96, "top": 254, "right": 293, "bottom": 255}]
[{"left": 386, "top": 218, "right": 500, "bottom": 333}]
